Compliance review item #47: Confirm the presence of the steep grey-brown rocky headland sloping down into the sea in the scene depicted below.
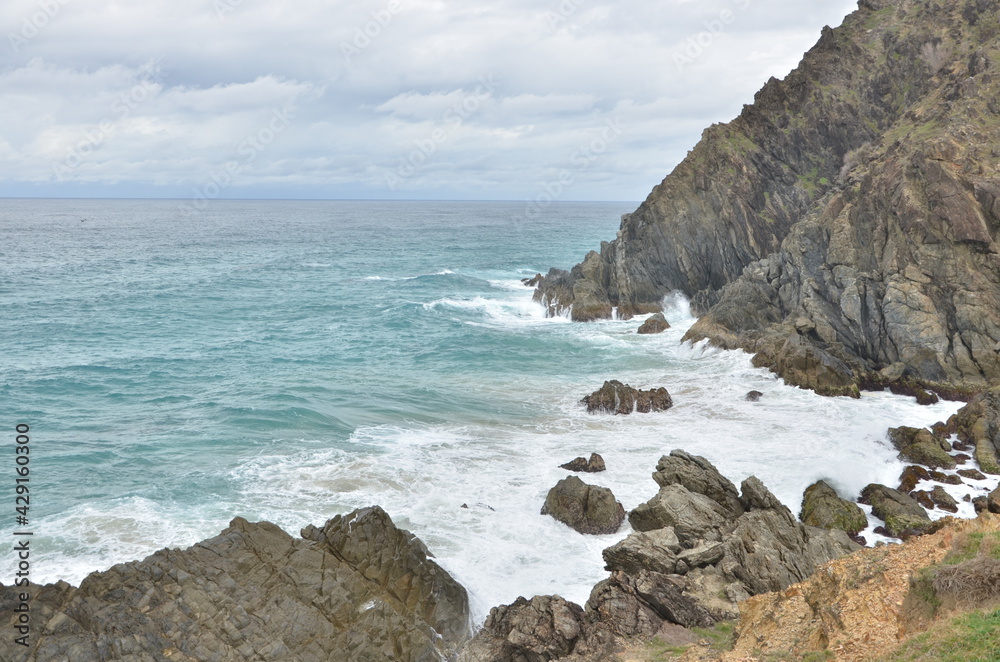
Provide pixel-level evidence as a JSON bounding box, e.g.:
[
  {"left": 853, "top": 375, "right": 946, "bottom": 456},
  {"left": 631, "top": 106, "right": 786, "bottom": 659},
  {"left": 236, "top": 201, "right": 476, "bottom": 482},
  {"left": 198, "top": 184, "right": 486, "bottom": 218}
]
[{"left": 535, "top": 0, "right": 1000, "bottom": 397}]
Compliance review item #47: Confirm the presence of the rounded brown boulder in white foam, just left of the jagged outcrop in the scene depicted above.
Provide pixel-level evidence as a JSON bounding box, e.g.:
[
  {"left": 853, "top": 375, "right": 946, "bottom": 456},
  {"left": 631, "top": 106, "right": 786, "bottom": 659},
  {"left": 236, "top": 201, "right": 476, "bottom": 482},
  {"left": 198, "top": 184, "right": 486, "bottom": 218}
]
[{"left": 542, "top": 476, "right": 625, "bottom": 534}]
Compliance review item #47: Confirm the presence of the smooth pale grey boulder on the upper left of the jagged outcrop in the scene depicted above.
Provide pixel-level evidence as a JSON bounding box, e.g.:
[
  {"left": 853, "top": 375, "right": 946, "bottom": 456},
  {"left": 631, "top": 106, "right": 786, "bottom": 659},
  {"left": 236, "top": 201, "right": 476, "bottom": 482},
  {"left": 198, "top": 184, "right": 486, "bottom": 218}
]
[{"left": 628, "top": 485, "right": 732, "bottom": 545}]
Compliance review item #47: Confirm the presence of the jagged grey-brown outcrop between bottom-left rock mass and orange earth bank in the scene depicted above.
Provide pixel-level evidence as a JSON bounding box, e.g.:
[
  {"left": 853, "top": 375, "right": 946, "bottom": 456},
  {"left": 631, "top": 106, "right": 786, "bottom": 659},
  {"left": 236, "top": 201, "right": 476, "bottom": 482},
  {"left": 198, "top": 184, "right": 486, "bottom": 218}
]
[{"left": 461, "top": 451, "right": 858, "bottom": 662}]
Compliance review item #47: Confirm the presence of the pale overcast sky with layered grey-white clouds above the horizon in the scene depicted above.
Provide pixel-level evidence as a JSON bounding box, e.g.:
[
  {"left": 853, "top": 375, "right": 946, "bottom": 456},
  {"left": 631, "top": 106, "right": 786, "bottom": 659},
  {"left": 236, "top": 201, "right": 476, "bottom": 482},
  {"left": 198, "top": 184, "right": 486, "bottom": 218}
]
[{"left": 0, "top": 0, "right": 855, "bottom": 201}]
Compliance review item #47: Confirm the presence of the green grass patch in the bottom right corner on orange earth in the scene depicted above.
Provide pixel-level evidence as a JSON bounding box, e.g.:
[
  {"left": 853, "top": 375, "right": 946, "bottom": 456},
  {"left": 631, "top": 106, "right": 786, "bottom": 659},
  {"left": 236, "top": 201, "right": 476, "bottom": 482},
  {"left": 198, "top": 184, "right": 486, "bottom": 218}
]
[{"left": 881, "top": 610, "right": 1000, "bottom": 662}]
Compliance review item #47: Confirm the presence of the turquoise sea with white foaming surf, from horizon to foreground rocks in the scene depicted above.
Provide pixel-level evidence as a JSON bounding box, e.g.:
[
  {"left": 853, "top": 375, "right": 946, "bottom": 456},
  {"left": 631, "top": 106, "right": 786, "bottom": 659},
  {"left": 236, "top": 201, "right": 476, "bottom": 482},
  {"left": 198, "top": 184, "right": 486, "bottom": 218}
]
[{"left": 0, "top": 200, "right": 984, "bottom": 620}]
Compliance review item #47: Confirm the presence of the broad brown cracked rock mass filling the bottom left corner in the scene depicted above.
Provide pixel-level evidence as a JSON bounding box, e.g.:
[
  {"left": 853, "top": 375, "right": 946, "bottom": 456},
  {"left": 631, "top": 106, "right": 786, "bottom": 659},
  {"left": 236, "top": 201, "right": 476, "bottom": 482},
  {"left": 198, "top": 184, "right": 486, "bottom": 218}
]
[{"left": 0, "top": 507, "right": 470, "bottom": 662}]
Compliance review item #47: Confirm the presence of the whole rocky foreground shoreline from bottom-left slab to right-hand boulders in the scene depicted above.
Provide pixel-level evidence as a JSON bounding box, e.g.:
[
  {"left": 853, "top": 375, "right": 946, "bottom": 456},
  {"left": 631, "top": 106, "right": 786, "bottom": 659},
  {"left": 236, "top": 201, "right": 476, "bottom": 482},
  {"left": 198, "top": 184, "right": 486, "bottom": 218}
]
[{"left": 0, "top": 388, "right": 1000, "bottom": 662}]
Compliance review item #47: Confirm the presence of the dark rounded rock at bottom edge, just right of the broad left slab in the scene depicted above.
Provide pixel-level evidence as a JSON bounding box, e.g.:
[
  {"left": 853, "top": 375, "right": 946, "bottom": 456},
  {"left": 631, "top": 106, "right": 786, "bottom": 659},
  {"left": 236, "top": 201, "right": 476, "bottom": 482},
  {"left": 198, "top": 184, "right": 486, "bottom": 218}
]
[{"left": 458, "top": 595, "right": 585, "bottom": 662}]
